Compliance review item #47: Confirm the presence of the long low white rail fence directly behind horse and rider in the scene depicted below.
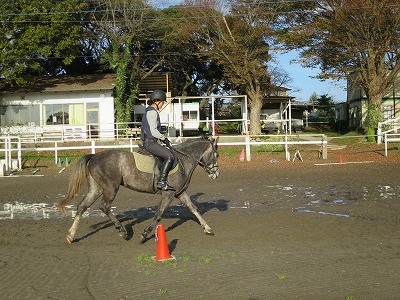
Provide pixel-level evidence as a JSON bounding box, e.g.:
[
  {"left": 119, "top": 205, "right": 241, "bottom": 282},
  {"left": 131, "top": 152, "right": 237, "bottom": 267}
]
[{"left": 0, "top": 134, "right": 328, "bottom": 170}]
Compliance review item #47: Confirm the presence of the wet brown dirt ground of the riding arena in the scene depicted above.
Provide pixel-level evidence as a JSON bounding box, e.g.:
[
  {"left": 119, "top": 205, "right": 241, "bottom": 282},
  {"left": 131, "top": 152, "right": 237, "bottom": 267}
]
[{"left": 0, "top": 146, "right": 400, "bottom": 299}]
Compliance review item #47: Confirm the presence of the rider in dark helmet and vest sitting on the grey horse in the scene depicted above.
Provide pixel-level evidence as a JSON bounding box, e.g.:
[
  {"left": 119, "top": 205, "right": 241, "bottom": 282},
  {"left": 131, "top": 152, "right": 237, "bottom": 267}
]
[{"left": 141, "top": 90, "right": 175, "bottom": 191}]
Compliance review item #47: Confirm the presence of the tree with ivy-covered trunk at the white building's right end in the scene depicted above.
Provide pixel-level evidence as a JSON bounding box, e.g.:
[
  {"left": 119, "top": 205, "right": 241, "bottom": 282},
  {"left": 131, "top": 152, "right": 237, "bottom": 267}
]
[{"left": 91, "top": 0, "right": 163, "bottom": 126}]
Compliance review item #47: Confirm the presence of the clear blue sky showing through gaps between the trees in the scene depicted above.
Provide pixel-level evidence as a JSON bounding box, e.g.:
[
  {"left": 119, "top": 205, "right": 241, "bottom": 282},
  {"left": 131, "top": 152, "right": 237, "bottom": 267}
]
[{"left": 159, "top": 0, "right": 346, "bottom": 103}]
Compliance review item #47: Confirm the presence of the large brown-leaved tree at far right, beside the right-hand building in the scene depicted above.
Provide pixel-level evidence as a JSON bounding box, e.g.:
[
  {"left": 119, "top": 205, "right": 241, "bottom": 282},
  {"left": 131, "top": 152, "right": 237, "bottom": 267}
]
[{"left": 282, "top": 0, "right": 400, "bottom": 128}]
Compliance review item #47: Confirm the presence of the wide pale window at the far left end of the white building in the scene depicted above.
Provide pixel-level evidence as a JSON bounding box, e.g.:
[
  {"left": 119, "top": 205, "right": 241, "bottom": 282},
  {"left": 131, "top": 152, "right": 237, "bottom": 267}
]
[{"left": 0, "top": 105, "right": 40, "bottom": 126}]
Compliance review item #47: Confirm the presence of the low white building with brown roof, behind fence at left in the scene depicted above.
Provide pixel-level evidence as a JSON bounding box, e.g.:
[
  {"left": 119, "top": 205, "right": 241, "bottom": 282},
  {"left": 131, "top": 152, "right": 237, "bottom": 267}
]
[{"left": 0, "top": 74, "right": 114, "bottom": 139}]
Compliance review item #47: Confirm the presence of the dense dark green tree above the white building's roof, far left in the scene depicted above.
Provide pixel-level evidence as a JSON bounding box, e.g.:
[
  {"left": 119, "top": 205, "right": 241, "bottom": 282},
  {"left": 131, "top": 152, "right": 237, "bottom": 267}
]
[{"left": 0, "top": 0, "right": 90, "bottom": 85}]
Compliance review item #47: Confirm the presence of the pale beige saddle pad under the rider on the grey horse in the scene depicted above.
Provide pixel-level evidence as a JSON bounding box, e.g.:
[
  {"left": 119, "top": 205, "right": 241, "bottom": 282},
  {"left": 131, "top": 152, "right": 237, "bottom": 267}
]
[{"left": 133, "top": 145, "right": 179, "bottom": 175}]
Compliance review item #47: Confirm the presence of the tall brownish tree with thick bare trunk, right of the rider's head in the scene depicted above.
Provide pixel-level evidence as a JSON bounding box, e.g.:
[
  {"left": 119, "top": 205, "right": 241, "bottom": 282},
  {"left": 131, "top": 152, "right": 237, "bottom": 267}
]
[{"left": 184, "top": 0, "right": 288, "bottom": 134}]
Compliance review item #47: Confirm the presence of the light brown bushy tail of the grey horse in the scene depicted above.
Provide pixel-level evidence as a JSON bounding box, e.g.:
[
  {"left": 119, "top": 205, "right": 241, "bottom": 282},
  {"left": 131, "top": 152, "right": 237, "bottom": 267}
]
[{"left": 56, "top": 154, "right": 93, "bottom": 214}]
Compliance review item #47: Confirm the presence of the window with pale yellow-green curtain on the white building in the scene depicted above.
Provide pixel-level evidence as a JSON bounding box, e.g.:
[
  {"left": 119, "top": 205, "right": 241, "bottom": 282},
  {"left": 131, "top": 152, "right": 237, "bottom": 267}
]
[{"left": 43, "top": 103, "right": 84, "bottom": 125}]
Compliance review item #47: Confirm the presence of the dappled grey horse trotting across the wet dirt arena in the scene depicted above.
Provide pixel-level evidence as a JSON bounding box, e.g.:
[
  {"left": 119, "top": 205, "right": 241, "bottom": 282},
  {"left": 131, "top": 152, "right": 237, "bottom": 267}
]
[{"left": 56, "top": 137, "right": 219, "bottom": 244}]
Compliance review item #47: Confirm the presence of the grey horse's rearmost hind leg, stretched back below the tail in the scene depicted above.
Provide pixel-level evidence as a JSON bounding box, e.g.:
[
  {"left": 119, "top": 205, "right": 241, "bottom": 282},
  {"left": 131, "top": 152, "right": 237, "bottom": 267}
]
[{"left": 67, "top": 178, "right": 102, "bottom": 244}]
